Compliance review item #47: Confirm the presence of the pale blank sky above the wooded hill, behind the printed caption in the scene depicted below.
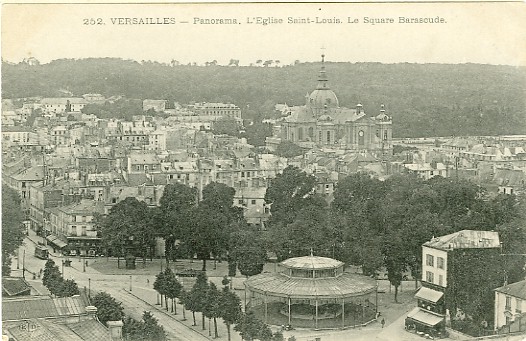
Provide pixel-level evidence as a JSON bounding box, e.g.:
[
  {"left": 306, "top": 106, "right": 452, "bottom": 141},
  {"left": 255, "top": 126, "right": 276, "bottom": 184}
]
[{"left": 1, "top": 2, "right": 526, "bottom": 66}]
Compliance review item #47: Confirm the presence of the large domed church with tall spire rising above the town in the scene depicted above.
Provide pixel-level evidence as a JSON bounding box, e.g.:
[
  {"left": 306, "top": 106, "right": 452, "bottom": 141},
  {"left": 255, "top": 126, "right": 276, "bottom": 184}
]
[{"left": 268, "top": 55, "right": 392, "bottom": 156}]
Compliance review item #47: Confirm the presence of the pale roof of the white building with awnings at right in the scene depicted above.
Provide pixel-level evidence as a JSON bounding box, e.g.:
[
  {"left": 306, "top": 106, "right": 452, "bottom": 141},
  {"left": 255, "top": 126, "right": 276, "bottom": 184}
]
[{"left": 423, "top": 230, "right": 500, "bottom": 250}]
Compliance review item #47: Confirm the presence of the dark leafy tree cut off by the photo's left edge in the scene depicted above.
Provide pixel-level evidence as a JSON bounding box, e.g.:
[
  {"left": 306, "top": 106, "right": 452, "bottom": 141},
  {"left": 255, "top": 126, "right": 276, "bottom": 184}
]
[{"left": 2, "top": 186, "right": 25, "bottom": 276}]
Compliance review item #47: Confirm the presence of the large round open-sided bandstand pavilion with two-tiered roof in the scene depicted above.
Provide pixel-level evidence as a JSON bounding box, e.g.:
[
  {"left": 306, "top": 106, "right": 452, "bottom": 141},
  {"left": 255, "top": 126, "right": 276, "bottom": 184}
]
[{"left": 245, "top": 254, "right": 378, "bottom": 329}]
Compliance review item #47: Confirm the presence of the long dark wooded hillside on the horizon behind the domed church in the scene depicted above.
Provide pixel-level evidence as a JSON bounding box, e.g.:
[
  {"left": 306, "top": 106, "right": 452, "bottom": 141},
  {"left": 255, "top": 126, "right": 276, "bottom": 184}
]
[{"left": 2, "top": 58, "right": 526, "bottom": 137}]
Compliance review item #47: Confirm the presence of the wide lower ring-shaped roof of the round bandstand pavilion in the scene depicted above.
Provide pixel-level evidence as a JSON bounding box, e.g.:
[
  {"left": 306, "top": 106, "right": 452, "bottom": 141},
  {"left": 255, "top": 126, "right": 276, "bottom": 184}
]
[{"left": 245, "top": 273, "right": 376, "bottom": 298}]
